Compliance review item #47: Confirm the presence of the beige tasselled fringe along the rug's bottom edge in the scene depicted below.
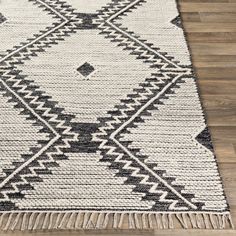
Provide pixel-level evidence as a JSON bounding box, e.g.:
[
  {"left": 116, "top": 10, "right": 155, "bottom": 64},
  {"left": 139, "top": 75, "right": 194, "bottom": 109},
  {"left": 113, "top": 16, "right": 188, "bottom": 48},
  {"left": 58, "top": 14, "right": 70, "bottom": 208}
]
[{"left": 0, "top": 212, "right": 234, "bottom": 231}]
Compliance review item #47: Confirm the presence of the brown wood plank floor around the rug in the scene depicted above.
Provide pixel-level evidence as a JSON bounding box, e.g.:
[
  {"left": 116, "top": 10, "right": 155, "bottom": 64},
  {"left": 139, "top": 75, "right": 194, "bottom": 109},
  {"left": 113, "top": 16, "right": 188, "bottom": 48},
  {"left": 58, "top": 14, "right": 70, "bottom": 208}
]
[{"left": 1, "top": 0, "right": 236, "bottom": 236}]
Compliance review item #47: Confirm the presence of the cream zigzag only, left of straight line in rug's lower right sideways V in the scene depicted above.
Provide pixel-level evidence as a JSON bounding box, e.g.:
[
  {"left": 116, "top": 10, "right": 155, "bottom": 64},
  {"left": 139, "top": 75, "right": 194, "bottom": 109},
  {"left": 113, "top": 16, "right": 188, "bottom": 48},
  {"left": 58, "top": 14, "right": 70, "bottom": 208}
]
[{"left": 94, "top": 74, "right": 196, "bottom": 210}]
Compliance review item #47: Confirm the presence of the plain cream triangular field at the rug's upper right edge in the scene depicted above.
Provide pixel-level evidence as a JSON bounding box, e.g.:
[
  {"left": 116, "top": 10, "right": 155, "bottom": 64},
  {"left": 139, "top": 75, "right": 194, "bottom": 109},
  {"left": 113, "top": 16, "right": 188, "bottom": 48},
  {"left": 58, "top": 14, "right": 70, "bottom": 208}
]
[{"left": 114, "top": 0, "right": 191, "bottom": 66}]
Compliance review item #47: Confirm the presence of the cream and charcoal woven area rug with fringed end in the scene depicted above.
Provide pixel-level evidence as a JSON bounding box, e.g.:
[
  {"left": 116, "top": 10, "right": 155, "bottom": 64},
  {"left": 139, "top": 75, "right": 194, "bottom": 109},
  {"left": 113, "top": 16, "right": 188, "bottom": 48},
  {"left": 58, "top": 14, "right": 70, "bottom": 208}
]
[{"left": 0, "top": 0, "right": 232, "bottom": 230}]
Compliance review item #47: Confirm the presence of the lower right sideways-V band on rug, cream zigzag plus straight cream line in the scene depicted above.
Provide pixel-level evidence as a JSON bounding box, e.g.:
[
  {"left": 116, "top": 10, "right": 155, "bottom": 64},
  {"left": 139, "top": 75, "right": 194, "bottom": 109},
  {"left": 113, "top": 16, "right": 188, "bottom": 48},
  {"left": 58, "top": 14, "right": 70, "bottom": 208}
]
[{"left": 91, "top": 70, "right": 196, "bottom": 210}]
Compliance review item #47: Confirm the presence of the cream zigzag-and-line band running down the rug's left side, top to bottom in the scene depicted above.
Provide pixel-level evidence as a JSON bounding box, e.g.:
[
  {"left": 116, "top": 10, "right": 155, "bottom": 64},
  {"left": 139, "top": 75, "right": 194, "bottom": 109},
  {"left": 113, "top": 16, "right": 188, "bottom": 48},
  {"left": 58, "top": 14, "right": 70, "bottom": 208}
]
[{"left": 0, "top": 0, "right": 79, "bottom": 202}]
